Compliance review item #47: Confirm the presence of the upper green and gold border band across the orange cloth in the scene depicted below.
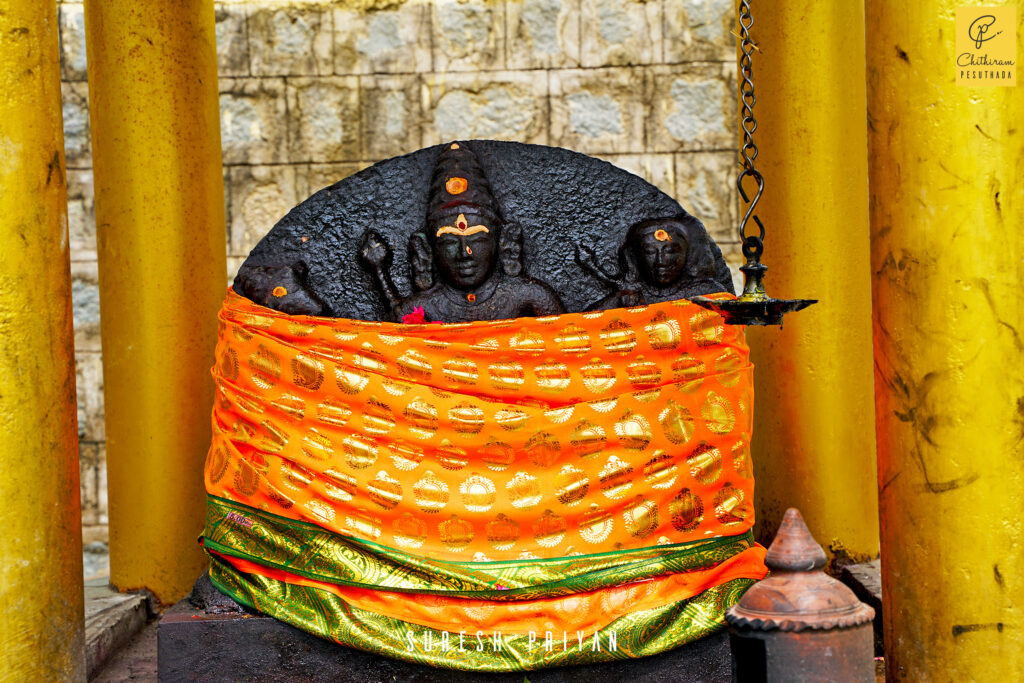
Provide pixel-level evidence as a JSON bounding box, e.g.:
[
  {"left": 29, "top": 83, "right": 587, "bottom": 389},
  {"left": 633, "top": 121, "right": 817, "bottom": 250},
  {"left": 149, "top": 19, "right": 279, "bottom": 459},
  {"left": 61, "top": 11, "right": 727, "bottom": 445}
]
[{"left": 201, "top": 496, "right": 754, "bottom": 600}]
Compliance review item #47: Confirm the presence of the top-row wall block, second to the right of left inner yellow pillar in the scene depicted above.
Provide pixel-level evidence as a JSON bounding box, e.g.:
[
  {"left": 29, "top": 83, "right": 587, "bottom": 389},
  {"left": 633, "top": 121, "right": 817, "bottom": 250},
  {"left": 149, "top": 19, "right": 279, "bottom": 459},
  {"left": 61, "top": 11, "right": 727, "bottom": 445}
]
[{"left": 248, "top": 3, "right": 334, "bottom": 76}]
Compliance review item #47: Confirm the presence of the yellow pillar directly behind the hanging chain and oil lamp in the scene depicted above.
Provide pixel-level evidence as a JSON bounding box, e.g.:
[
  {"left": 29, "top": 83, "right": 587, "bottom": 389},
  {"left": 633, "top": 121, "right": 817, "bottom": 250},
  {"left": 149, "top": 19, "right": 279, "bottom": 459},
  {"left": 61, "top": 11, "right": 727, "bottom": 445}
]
[{"left": 748, "top": 0, "right": 879, "bottom": 560}]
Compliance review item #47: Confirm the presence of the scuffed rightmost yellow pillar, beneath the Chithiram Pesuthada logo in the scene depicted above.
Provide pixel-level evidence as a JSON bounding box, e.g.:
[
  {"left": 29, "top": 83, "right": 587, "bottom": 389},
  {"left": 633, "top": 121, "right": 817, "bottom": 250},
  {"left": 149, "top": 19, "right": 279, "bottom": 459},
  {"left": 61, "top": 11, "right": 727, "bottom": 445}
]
[{"left": 867, "top": 0, "right": 1024, "bottom": 681}]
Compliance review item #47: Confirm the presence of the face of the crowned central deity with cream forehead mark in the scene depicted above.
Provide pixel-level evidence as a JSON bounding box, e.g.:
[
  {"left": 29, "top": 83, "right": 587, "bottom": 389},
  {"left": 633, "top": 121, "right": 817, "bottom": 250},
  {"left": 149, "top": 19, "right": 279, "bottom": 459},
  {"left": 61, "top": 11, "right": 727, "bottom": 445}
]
[{"left": 429, "top": 214, "right": 498, "bottom": 291}]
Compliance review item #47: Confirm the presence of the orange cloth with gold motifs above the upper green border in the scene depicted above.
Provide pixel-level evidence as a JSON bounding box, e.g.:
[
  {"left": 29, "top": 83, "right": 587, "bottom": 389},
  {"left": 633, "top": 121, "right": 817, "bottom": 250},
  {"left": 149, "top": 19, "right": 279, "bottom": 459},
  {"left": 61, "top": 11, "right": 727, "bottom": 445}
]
[{"left": 206, "top": 292, "right": 754, "bottom": 562}]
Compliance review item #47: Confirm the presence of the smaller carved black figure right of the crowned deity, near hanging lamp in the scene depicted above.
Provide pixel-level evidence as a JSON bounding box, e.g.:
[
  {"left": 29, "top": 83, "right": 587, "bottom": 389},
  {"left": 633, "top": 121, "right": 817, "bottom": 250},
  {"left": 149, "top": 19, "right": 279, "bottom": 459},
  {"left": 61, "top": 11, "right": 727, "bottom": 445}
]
[{"left": 577, "top": 214, "right": 731, "bottom": 309}]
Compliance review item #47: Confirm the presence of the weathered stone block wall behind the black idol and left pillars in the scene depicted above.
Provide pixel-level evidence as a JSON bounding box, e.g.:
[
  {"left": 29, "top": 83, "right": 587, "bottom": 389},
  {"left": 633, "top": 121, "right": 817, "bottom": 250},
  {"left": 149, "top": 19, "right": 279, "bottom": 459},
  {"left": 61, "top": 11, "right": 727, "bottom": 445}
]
[{"left": 60, "top": 0, "right": 739, "bottom": 540}]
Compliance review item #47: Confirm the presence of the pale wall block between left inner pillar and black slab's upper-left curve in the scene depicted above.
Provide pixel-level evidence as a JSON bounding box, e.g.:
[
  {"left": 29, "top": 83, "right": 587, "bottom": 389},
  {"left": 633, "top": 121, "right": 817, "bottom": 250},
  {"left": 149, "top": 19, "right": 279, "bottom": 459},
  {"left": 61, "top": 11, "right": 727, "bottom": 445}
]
[{"left": 227, "top": 165, "right": 299, "bottom": 257}]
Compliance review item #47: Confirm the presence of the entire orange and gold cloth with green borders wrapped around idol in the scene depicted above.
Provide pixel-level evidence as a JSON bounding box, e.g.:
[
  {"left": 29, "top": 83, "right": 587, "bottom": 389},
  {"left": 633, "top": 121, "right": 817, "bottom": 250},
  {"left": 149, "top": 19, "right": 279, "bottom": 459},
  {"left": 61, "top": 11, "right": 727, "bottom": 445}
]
[{"left": 201, "top": 292, "right": 766, "bottom": 672}]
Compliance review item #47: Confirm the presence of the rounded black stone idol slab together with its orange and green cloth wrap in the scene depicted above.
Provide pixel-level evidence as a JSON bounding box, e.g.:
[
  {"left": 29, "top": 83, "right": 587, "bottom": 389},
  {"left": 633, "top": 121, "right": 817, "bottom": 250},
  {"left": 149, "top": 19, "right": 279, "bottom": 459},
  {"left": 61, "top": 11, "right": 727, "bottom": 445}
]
[{"left": 195, "top": 140, "right": 753, "bottom": 677}]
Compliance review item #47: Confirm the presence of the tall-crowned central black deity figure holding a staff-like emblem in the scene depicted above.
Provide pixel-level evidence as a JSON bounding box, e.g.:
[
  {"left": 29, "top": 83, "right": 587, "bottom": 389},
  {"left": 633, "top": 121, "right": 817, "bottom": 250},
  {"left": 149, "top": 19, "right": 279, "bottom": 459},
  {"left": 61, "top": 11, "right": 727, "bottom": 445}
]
[{"left": 359, "top": 142, "right": 564, "bottom": 323}]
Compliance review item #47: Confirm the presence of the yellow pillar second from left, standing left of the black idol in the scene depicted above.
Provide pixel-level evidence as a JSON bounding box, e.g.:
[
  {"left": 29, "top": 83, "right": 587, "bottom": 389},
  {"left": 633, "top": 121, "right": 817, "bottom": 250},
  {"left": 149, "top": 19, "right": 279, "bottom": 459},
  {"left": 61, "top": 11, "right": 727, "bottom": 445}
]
[{"left": 85, "top": 0, "right": 226, "bottom": 603}]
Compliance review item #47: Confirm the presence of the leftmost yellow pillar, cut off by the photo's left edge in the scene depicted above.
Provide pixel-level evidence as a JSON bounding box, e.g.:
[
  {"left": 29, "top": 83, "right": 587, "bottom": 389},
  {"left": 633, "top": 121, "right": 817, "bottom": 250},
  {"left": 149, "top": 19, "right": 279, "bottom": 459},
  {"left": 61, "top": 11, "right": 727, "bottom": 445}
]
[{"left": 0, "top": 0, "right": 85, "bottom": 681}]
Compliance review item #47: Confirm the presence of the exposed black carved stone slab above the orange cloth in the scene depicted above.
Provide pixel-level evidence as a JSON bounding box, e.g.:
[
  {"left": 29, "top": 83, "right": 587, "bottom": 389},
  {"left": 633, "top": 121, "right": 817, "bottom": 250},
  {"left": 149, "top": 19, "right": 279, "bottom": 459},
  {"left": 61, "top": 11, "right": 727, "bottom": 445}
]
[{"left": 234, "top": 140, "right": 733, "bottom": 323}]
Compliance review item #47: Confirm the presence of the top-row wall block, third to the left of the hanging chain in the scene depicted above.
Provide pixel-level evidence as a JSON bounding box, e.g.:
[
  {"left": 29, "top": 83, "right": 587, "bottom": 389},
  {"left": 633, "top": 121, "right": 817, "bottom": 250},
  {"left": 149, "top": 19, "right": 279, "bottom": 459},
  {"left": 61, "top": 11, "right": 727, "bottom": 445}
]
[{"left": 505, "top": 0, "right": 580, "bottom": 69}]
